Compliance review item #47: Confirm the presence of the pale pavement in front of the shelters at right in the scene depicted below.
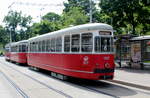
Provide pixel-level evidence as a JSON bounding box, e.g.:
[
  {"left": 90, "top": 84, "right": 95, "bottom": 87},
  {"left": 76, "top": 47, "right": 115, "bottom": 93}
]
[{"left": 113, "top": 64, "right": 150, "bottom": 90}]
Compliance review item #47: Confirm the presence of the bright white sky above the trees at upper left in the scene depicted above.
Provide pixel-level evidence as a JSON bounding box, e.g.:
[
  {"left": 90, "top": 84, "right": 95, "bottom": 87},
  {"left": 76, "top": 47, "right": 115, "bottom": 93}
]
[{"left": 0, "top": 0, "right": 67, "bottom": 25}]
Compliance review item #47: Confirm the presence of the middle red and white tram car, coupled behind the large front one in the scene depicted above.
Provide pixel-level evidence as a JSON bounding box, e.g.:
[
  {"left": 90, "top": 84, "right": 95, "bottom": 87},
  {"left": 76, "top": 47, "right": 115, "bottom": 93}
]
[{"left": 7, "top": 40, "right": 28, "bottom": 64}]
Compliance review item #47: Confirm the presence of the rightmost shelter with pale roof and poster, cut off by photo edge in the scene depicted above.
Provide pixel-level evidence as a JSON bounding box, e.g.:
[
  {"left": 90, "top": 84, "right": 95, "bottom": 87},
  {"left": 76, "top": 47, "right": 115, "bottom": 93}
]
[{"left": 130, "top": 35, "right": 150, "bottom": 69}]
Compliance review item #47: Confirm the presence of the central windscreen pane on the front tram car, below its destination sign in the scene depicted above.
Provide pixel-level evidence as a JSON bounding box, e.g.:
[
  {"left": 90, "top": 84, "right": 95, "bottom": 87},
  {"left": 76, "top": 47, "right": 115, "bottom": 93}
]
[{"left": 101, "top": 37, "right": 111, "bottom": 52}]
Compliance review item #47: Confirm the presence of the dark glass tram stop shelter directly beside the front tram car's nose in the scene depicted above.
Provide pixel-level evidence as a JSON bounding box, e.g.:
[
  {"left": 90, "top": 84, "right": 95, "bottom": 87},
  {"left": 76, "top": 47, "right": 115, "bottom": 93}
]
[{"left": 114, "top": 34, "right": 136, "bottom": 68}]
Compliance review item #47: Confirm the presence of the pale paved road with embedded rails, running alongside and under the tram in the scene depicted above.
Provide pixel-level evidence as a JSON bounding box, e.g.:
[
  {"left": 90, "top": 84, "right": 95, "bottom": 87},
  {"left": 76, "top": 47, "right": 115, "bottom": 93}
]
[{"left": 0, "top": 57, "right": 150, "bottom": 98}]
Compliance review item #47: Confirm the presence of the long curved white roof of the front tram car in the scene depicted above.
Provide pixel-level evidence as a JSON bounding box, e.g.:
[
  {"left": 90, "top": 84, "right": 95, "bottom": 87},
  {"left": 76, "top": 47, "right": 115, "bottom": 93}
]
[{"left": 29, "top": 23, "right": 113, "bottom": 41}]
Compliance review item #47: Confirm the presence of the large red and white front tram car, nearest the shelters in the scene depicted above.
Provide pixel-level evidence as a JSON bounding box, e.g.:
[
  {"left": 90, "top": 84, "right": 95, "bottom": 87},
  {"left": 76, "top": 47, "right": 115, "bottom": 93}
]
[{"left": 27, "top": 23, "right": 115, "bottom": 80}]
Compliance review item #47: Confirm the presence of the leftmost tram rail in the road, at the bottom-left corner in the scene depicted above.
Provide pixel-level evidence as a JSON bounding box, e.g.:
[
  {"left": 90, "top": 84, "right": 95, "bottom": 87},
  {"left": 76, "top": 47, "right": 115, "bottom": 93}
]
[{"left": 0, "top": 70, "right": 30, "bottom": 98}]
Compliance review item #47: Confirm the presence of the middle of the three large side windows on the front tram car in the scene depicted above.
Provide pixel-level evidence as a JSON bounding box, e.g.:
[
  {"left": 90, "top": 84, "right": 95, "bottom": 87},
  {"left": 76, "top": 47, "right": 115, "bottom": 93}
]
[{"left": 71, "top": 34, "right": 80, "bottom": 52}]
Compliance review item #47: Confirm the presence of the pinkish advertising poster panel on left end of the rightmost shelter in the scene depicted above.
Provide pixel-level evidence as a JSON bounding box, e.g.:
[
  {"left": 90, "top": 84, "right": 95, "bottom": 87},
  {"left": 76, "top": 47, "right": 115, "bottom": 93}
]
[{"left": 131, "top": 41, "right": 141, "bottom": 68}]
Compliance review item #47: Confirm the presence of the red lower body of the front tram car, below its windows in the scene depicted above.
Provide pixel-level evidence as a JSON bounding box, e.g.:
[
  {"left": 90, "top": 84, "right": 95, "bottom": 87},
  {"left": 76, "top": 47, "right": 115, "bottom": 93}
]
[{"left": 28, "top": 53, "right": 114, "bottom": 80}]
